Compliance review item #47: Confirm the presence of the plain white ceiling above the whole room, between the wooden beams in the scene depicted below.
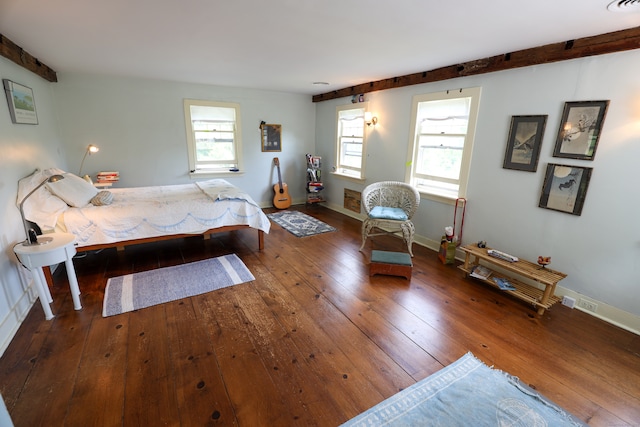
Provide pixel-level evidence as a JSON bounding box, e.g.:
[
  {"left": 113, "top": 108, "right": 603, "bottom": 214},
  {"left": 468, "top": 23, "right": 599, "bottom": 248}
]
[{"left": 0, "top": 0, "right": 640, "bottom": 95}]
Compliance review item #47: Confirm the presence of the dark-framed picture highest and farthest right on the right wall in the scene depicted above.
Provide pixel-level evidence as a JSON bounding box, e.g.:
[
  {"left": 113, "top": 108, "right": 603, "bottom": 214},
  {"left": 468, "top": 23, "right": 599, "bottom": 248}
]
[{"left": 553, "top": 101, "right": 609, "bottom": 160}]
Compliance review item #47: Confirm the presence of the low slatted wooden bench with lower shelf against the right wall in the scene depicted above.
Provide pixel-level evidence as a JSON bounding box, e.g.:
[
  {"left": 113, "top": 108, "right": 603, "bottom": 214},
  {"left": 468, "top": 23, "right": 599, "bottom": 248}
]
[{"left": 458, "top": 244, "right": 567, "bottom": 315}]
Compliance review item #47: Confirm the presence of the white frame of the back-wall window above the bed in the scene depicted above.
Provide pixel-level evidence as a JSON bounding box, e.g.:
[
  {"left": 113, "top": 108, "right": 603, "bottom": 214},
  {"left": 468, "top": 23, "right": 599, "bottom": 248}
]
[{"left": 184, "top": 99, "right": 243, "bottom": 177}]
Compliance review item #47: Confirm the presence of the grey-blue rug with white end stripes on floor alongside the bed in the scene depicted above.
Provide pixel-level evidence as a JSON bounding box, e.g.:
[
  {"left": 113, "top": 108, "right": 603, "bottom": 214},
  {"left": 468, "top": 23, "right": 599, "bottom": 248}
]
[{"left": 102, "top": 254, "right": 255, "bottom": 317}]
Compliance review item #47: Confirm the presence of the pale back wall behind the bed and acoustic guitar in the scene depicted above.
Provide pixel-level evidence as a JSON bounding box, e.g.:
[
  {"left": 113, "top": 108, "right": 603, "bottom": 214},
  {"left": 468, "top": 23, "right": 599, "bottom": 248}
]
[{"left": 52, "top": 73, "right": 315, "bottom": 206}]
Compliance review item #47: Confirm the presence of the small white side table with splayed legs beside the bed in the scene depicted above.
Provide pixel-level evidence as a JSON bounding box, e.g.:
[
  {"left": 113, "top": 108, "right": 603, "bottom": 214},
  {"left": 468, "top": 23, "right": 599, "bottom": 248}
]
[{"left": 13, "top": 233, "right": 82, "bottom": 320}]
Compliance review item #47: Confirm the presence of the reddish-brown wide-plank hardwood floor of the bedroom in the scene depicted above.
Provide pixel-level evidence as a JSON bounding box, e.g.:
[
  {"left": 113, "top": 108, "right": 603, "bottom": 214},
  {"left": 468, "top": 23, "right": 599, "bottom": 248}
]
[{"left": 0, "top": 206, "right": 640, "bottom": 426}]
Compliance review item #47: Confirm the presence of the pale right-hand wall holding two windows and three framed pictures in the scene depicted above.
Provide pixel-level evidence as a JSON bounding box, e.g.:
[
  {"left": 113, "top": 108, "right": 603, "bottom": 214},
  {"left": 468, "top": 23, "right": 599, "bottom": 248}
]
[{"left": 316, "top": 51, "right": 640, "bottom": 332}]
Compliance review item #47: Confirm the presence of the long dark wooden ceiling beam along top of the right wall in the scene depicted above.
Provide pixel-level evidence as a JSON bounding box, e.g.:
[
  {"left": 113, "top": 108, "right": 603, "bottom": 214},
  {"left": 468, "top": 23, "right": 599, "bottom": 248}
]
[{"left": 313, "top": 27, "right": 640, "bottom": 102}]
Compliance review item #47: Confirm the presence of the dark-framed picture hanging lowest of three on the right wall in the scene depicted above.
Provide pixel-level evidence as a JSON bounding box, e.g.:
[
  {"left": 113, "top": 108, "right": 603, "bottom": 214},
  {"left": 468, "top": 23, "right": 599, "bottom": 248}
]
[{"left": 538, "top": 163, "right": 593, "bottom": 215}]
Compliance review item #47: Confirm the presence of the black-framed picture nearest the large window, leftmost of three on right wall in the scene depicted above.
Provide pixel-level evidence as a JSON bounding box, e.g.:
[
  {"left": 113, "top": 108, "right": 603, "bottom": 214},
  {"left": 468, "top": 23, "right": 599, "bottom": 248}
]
[{"left": 502, "top": 115, "right": 547, "bottom": 172}]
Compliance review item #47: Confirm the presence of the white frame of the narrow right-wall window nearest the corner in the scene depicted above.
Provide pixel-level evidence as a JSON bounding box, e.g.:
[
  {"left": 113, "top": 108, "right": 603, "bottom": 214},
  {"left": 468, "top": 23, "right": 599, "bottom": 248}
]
[{"left": 333, "top": 102, "right": 369, "bottom": 181}]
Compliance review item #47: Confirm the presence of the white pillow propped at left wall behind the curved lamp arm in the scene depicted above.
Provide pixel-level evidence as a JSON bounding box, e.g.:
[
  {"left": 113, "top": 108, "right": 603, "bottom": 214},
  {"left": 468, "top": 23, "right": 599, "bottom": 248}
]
[{"left": 16, "top": 168, "right": 69, "bottom": 230}]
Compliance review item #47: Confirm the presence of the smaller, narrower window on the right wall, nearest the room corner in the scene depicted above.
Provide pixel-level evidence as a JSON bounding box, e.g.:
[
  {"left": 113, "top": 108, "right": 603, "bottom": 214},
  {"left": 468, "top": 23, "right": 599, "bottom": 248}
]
[{"left": 336, "top": 102, "right": 368, "bottom": 179}]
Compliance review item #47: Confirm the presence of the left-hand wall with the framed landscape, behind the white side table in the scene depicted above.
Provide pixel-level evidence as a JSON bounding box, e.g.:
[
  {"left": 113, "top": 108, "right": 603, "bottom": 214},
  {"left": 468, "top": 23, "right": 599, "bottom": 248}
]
[{"left": 0, "top": 57, "right": 66, "bottom": 354}]
